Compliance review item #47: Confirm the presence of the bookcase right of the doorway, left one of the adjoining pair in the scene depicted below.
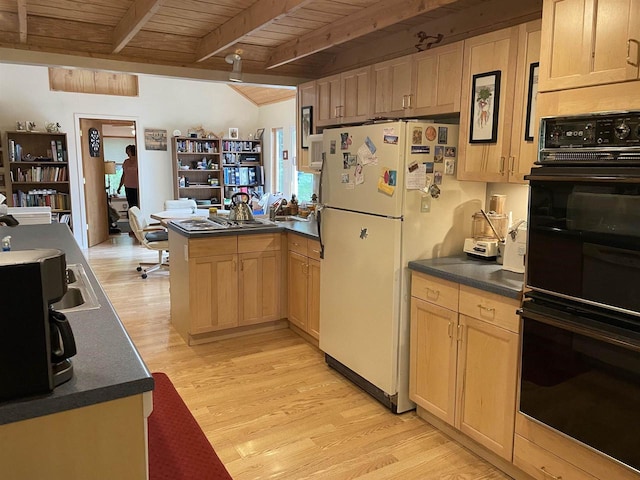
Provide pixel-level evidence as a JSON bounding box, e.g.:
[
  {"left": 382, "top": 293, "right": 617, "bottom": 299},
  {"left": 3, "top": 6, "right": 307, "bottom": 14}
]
[{"left": 172, "top": 137, "right": 223, "bottom": 207}]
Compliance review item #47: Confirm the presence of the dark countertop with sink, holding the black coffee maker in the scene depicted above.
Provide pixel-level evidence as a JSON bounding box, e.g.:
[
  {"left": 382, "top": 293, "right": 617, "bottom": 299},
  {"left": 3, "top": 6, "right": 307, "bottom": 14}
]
[{"left": 0, "top": 224, "right": 153, "bottom": 425}]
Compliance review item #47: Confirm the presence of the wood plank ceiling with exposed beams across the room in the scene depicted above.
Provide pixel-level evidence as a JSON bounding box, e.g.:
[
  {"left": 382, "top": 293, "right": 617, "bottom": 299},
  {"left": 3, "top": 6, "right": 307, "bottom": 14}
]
[{"left": 0, "top": 0, "right": 542, "bottom": 85}]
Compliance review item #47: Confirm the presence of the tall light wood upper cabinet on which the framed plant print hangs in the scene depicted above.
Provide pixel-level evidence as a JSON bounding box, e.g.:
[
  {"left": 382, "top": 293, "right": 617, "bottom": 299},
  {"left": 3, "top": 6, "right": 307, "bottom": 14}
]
[{"left": 458, "top": 20, "right": 540, "bottom": 183}]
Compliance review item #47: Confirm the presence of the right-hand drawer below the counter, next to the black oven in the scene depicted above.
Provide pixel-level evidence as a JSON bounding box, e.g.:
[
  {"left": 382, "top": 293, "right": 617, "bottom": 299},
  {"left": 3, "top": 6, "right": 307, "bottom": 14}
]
[{"left": 460, "top": 285, "right": 520, "bottom": 333}]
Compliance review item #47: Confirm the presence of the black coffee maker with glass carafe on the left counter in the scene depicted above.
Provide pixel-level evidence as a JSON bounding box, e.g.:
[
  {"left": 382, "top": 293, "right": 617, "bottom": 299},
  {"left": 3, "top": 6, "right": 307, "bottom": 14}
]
[{"left": 0, "top": 249, "right": 76, "bottom": 401}]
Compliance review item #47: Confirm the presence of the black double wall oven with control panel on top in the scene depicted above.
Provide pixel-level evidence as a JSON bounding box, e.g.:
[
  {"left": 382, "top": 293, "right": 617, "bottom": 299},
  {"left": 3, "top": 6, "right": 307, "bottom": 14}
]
[{"left": 519, "top": 112, "right": 640, "bottom": 471}]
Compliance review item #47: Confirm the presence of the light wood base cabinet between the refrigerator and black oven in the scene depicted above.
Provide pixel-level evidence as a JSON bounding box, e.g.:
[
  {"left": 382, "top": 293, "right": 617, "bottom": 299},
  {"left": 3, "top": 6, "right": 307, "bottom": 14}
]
[{"left": 409, "top": 272, "right": 519, "bottom": 461}]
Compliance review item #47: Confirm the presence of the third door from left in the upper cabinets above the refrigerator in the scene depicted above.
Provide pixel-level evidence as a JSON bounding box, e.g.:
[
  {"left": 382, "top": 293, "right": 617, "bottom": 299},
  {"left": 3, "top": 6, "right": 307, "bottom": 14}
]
[{"left": 372, "top": 55, "right": 412, "bottom": 117}]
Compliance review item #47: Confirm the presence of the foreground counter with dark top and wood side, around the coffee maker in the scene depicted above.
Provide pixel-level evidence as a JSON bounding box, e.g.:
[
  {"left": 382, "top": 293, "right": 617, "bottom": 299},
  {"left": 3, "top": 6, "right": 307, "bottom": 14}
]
[{"left": 0, "top": 224, "right": 153, "bottom": 480}]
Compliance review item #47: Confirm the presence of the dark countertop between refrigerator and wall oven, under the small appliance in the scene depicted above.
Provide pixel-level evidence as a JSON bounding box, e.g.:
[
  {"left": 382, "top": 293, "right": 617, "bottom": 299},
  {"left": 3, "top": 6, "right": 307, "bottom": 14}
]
[{"left": 409, "top": 254, "right": 524, "bottom": 299}]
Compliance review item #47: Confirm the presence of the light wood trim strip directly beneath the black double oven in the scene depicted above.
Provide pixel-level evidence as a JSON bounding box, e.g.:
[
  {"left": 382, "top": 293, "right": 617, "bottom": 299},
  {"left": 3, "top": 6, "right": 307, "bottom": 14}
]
[{"left": 515, "top": 413, "right": 640, "bottom": 480}]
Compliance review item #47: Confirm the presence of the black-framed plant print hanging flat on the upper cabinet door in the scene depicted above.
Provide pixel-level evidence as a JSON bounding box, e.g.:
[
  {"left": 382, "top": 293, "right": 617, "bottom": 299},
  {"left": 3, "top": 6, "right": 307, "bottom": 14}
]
[{"left": 469, "top": 70, "right": 501, "bottom": 143}]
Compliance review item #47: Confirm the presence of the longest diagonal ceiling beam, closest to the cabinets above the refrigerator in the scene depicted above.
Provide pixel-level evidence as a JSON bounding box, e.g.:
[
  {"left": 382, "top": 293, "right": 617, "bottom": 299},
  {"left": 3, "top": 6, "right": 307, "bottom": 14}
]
[{"left": 266, "top": 0, "right": 459, "bottom": 69}]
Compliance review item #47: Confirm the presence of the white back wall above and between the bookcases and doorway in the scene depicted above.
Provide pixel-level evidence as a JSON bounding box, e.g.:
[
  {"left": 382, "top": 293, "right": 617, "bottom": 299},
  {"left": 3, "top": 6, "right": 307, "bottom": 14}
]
[{"left": 0, "top": 64, "right": 266, "bottom": 247}]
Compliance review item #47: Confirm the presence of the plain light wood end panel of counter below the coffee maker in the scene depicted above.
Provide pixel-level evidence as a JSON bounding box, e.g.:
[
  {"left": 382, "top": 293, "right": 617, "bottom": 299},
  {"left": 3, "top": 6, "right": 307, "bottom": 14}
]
[{"left": 0, "top": 394, "right": 147, "bottom": 480}]
